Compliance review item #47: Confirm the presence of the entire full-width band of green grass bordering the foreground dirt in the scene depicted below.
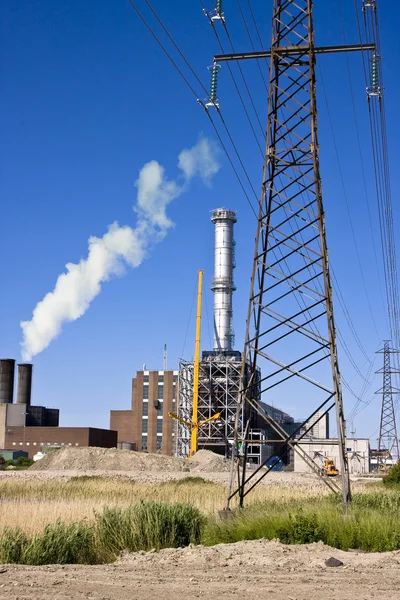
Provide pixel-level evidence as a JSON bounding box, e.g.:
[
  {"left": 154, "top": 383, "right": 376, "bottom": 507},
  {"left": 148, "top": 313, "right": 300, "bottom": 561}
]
[{"left": 0, "top": 492, "right": 400, "bottom": 565}]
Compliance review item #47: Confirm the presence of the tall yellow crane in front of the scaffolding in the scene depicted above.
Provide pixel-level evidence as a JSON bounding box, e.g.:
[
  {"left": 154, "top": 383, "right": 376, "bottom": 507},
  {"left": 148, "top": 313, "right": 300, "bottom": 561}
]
[{"left": 168, "top": 271, "right": 221, "bottom": 458}]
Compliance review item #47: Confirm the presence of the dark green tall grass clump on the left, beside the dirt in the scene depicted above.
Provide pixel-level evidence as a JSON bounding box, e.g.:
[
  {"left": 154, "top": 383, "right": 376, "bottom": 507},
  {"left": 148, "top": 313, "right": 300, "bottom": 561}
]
[{"left": 0, "top": 502, "right": 204, "bottom": 565}]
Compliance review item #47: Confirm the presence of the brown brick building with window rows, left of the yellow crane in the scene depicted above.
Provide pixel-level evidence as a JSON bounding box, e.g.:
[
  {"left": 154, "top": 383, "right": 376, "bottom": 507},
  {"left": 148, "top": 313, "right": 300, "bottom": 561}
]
[{"left": 110, "top": 371, "right": 178, "bottom": 456}]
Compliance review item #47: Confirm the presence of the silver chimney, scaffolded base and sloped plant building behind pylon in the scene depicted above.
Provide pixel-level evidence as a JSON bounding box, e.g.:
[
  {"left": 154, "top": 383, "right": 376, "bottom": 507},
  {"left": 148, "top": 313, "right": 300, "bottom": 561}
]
[{"left": 176, "top": 208, "right": 320, "bottom": 464}]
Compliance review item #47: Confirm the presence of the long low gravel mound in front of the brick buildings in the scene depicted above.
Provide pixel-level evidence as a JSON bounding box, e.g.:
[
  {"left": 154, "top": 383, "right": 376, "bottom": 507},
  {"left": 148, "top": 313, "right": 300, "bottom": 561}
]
[{"left": 30, "top": 447, "right": 189, "bottom": 471}]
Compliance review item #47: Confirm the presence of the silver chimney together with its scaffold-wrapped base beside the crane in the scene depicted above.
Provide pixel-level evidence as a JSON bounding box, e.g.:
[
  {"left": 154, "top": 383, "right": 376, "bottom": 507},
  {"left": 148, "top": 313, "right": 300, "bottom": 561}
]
[{"left": 177, "top": 208, "right": 252, "bottom": 457}]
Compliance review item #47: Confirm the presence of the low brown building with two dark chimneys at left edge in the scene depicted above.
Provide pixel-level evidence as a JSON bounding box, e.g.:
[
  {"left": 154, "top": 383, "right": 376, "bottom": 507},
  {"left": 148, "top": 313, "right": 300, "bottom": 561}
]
[{"left": 0, "top": 358, "right": 117, "bottom": 458}]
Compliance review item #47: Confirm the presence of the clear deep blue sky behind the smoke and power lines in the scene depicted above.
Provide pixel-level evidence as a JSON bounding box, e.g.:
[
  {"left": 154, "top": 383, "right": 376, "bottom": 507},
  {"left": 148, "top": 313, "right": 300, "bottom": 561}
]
[{"left": 0, "top": 0, "right": 400, "bottom": 438}]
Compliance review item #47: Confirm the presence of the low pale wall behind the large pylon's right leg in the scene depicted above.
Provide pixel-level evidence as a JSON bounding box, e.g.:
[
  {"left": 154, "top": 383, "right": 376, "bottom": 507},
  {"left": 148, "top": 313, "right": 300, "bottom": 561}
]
[{"left": 294, "top": 439, "right": 369, "bottom": 474}]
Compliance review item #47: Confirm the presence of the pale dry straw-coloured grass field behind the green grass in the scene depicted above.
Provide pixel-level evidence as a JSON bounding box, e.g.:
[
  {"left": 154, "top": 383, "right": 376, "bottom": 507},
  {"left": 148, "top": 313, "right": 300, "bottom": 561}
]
[{"left": 0, "top": 477, "right": 374, "bottom": 533}]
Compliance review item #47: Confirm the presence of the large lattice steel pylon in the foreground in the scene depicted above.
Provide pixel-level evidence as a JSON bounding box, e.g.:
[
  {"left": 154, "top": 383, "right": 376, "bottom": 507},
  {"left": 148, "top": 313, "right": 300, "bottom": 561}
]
[{"left": 214, "top": 0, "right": 374, "bottom": 508}]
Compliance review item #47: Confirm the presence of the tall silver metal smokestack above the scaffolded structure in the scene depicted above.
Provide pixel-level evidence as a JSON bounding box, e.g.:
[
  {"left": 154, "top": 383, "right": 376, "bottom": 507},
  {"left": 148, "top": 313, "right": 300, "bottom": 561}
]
[{"left": 211, "top": 208, "right": 236, "bottom": 351}]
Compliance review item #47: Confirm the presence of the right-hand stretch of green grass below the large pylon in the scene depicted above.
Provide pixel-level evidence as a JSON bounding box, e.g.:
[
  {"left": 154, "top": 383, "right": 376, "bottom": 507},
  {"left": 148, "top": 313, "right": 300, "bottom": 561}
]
[{"left": 202, "top": 491, "right": 400, "bottom": 552}]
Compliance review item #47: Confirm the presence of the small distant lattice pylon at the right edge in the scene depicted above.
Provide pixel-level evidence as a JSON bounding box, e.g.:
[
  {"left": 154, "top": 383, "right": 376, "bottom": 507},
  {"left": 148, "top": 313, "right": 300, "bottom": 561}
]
[{"left": 375, "top": 340, "right": 400, "bottom": 469}]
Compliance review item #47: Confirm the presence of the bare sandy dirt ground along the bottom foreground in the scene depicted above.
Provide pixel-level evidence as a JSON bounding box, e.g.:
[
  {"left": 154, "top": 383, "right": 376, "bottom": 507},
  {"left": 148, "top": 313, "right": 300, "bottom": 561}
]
[{"left": 0, "top": 540, "right": 400, "bottom": 600}]
